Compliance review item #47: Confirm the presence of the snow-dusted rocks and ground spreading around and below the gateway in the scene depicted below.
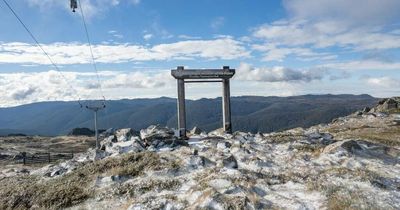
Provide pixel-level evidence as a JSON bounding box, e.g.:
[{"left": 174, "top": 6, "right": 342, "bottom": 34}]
[{"left": 10, "top": 118, "right": 400, "bottom": 209}]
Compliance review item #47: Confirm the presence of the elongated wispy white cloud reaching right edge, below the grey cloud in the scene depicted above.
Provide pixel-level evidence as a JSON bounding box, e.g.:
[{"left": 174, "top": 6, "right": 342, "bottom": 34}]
[{"left": 253, "top": 21, "right": 400, "bottom": 50}]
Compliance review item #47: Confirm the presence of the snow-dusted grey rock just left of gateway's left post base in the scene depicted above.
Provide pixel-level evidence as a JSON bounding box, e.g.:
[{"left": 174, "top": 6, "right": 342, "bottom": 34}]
[{"left": 140, "top": 125, "right": 176, "bottom": 145}]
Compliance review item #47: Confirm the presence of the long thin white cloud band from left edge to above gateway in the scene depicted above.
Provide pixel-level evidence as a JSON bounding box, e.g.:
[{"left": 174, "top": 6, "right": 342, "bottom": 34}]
[{"left": 0, "top": 38, "right": 250, "bottom": 65}]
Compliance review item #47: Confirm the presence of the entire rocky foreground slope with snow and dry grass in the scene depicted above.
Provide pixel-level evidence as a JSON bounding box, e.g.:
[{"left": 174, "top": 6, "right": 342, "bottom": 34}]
[{"left": 0, "top": 98, "right": 400, "bottom": 209}]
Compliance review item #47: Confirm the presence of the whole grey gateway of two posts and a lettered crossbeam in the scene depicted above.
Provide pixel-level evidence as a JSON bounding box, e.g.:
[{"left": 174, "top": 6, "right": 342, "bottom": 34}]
[{"left": 171, "top": 66, "right": 235, "bottom": 138}]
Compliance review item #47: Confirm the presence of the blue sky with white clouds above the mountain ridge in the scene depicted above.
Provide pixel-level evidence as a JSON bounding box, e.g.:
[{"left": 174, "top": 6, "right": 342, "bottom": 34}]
[{"left": 0, "top": 0, "right": 400, "bottom": 107}]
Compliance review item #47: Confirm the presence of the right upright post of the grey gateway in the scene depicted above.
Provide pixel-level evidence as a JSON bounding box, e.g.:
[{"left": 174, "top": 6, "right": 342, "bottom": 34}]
[{"left": 222, "top": 79, "right": 232, "bottom": 133}]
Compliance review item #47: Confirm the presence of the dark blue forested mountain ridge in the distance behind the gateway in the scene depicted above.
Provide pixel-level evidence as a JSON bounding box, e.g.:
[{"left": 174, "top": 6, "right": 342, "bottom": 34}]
[{"left": 0, "top": 94, "right": 379, "bottom": 136}]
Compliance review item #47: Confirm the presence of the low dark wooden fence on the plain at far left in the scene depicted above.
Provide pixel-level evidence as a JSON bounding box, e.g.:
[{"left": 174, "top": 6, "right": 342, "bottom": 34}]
[{"left": 19, "top": 152, "right": 74, "bottom": 165}]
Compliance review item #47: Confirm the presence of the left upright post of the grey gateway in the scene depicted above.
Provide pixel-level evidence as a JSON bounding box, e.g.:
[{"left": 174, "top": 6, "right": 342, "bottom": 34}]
[{"left": 177, "top": 67, "right": 186, "bottom": 139}]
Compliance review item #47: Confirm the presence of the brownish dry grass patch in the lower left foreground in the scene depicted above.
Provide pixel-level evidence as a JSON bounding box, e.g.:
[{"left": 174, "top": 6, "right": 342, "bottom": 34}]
[{"left": 0, "top": 152, "right": 178, "bottom": 209}]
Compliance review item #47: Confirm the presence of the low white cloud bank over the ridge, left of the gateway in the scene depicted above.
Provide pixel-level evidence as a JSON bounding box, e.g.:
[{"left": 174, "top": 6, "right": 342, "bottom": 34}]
[{"left": 0, "top": 70, "right": 175, "bottom": 106}]
